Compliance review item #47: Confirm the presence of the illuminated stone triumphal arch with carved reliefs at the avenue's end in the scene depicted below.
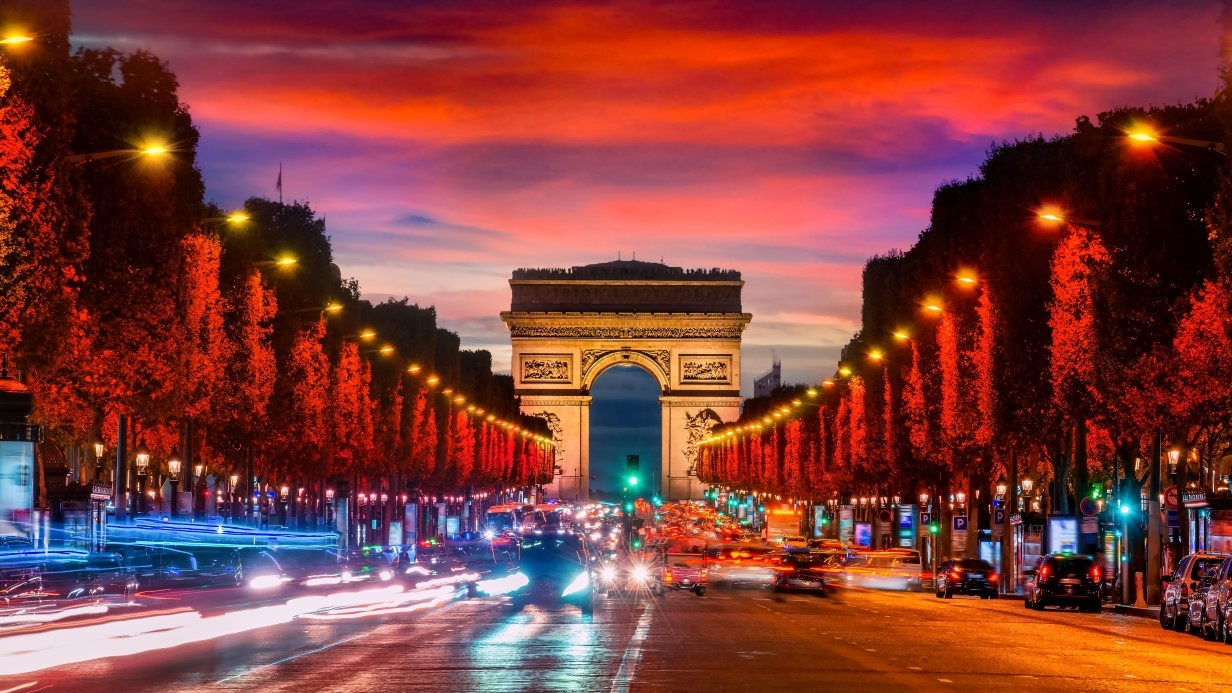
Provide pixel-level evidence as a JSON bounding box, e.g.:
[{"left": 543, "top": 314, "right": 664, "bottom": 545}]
[{"left": 500, "top": 260, "right": 753, "bottom": 499}]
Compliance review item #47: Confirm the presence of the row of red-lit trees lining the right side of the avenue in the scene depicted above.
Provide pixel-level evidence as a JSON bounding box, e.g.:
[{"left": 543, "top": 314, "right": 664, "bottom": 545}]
[{"left": 700, "top": 92, "right": 1232, "bottom": 522}]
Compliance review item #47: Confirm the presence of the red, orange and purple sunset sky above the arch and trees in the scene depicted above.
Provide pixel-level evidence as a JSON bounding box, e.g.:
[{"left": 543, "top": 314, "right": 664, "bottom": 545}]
[{"left": 73, "top": 0, "right": 1220, "bottom": 395}]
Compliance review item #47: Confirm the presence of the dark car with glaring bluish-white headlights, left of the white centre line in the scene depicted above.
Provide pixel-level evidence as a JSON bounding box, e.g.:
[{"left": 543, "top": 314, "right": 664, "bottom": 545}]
[{"left": 502, "top": 534, "right": 595, "bottom": 614}]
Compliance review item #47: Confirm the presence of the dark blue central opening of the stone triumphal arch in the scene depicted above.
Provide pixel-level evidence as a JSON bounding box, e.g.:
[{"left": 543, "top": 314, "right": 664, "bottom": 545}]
[{"left": 589, "top": 364, "right": 663, "bottom": 502}]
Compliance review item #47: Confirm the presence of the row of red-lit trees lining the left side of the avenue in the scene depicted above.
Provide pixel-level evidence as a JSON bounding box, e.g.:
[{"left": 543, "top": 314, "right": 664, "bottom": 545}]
[{"left": 0, "top": 0, "right": 553, "bottom": 491}]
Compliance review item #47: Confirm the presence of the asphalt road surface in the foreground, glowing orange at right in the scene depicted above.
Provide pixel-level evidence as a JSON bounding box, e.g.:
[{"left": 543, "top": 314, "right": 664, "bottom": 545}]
[{"left": 0, "top": 582, "right": 1232, "bottom": 693}]
